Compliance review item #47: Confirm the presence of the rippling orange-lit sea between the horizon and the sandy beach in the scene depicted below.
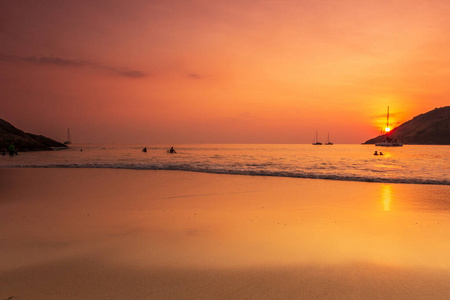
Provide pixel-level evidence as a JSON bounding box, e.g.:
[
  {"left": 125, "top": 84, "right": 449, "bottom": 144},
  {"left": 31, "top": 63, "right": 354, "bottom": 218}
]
[{"left": 0, "top": 145, "right": 450, "bottom": 185}]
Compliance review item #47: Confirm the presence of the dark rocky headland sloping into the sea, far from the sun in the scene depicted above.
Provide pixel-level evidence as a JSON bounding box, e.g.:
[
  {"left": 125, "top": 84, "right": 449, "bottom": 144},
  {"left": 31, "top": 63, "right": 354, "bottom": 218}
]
[{"left": 0, "top": 119, "right": 67, "bottom": 152}]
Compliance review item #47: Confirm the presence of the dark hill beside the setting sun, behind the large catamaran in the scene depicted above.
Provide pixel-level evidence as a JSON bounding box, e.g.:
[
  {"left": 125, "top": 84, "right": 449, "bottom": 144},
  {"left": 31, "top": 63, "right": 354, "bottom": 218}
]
[{"left": 364, "top": 106, "right": 450, "bottom": 145}]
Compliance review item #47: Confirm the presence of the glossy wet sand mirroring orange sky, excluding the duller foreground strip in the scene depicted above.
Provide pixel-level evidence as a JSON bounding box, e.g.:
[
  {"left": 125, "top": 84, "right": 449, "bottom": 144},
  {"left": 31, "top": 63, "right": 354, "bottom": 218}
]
[{"left": 0, "top": 169, "right": 450, "bottom": 271}]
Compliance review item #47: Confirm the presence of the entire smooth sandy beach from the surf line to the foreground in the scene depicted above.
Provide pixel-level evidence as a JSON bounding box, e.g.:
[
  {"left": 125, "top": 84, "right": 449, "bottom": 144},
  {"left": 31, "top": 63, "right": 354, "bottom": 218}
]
[{"left": 0, "top": 168, "right": 450, "bottom": 300}]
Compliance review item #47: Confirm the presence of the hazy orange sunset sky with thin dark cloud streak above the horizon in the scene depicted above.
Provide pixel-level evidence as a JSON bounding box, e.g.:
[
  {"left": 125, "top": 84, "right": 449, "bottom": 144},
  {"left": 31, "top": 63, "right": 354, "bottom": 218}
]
[{"left": 0, "top": 0, "right": 450, "bottom": 145}]
